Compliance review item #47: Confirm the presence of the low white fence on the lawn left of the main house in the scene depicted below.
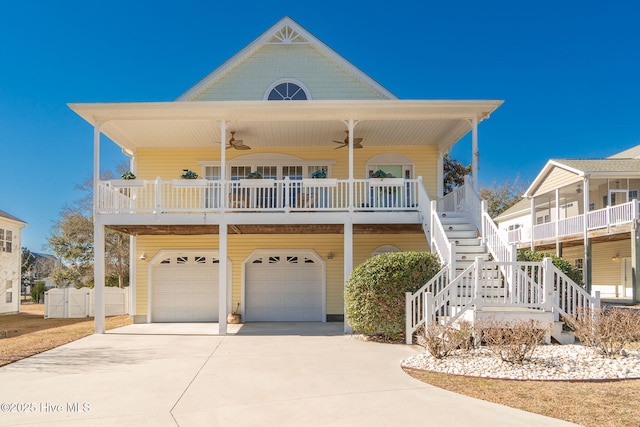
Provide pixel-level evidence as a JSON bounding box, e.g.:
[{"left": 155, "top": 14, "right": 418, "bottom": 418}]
[{"left": 44, "top": 287, "right": 129, "bottom": 319}]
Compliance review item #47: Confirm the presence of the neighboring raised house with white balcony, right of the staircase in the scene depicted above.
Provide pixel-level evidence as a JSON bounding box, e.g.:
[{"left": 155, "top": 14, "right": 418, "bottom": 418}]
[{"left": 495, "top": 145, "right": 640, "bottom": 303}]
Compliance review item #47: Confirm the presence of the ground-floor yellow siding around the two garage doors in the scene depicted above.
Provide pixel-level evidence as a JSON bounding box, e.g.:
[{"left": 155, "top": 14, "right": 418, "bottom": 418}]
[{"left": 136, "top": 234, "right": 428, "bottom": 315}]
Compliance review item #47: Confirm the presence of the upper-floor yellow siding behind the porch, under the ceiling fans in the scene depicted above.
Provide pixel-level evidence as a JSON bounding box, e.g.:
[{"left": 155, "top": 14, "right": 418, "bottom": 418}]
[{"left": 136, "top": 145, "right": 438, "bottom": 198}]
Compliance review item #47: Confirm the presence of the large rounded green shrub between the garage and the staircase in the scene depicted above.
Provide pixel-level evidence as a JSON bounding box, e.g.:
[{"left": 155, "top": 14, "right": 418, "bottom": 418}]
[{"left": 345, "top": 252, "right": 440, "bottom": 340}]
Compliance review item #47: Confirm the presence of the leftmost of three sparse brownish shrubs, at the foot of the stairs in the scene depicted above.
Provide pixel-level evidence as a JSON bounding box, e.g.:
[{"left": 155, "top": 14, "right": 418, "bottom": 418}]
[{"left": 424, "top": 322, "right": 473, "bottom": 359}]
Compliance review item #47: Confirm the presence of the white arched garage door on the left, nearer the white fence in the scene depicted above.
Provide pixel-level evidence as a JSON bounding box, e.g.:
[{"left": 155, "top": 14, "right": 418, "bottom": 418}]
[{"left": 151, "top": 255, "right": 219, "bottom": 322}]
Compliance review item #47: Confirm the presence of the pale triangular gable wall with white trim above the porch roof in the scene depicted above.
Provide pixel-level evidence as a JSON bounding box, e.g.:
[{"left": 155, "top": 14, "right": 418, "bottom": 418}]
[{"left": 177, "top": 17, "right": 397, "bottom": 101}]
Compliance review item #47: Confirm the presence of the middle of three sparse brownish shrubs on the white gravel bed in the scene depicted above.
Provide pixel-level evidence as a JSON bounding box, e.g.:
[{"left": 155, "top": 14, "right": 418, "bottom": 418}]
[{"left": 476, "top": 319, "right": 547, "bottom": 364}]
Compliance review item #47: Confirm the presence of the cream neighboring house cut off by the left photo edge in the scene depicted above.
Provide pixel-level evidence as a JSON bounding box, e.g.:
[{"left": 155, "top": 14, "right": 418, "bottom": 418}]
[{"left": 0, "top": 211, "right": 27, "bottom": 314}]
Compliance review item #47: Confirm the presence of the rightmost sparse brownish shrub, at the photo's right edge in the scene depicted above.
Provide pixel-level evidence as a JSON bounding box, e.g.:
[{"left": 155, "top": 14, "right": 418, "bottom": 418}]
[{"left": 564, "top": 308, "right": 640, "bottom": 358}]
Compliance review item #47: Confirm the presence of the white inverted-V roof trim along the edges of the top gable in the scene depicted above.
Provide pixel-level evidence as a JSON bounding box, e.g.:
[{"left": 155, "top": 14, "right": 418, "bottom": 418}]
[{"left": 176, "top": 16, "right": 398, "bottom": 101}]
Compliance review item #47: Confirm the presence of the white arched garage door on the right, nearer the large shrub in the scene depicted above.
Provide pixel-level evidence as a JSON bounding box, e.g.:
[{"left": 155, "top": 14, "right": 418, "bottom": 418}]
[{"left": 245, "top": 250, "right": 324, "bottom": 322}]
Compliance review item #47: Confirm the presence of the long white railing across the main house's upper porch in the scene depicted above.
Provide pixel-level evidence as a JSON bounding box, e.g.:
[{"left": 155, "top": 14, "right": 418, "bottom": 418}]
[{"left": 96, "top": 178, "right": 428, "bottom": 214}]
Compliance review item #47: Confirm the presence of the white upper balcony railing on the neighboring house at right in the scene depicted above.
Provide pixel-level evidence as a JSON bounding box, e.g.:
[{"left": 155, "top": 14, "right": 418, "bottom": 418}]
[{"left": 508, "top": 200, "right": 640, "bottom": 243}]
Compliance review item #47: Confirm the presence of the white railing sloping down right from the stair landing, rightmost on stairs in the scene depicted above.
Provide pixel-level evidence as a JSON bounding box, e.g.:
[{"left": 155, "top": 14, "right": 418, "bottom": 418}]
[{"left": 547, "top": 262, "right": 600, "bottom": 320}]
